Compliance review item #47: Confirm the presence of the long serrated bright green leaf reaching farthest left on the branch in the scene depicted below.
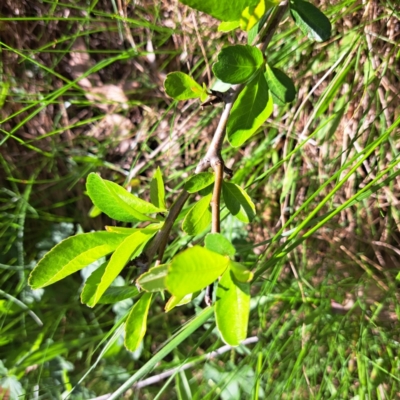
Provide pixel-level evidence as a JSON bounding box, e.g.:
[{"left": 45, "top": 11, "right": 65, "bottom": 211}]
[{"left": 29, "top": 232, "right": 126, "bottom": 289}]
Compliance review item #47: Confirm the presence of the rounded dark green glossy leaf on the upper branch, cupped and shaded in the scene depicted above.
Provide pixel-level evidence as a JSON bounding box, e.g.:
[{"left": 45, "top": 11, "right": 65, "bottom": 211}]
[{"left": 212, "top": 45, "right": 264, "bottom": 84}]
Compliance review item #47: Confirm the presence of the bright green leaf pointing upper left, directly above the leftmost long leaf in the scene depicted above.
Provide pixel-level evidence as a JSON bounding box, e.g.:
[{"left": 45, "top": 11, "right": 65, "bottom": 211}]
[{"left": 86, "top": 173, "right": 161, "bottom": 222}]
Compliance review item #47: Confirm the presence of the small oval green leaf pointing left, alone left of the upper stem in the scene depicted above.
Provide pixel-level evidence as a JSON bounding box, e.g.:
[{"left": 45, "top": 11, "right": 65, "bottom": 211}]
[{"left": 164, "top": 72, "right": 203, "bottom": 100}]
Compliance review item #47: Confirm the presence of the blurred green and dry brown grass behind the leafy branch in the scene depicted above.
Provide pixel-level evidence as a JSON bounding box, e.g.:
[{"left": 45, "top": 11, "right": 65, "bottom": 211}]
[{"left": 0, "top": 0, "right": 400, "bottom": 399}]
